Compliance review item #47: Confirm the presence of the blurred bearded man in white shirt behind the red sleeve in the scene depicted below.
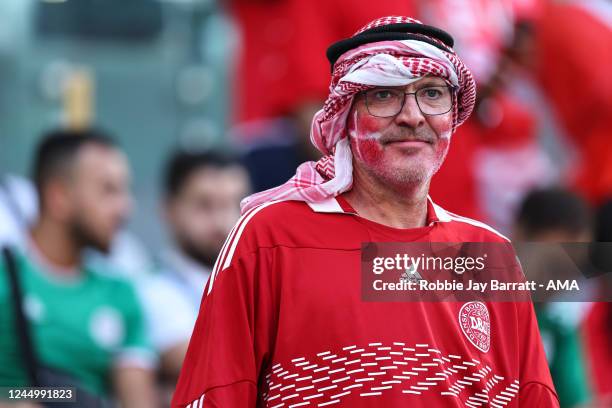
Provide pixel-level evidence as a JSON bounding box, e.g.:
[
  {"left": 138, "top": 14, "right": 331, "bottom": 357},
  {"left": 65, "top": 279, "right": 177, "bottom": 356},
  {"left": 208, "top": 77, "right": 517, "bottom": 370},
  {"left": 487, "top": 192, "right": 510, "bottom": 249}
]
[{"left": 142, "top": 151, "right": 249, "bottom": 384}]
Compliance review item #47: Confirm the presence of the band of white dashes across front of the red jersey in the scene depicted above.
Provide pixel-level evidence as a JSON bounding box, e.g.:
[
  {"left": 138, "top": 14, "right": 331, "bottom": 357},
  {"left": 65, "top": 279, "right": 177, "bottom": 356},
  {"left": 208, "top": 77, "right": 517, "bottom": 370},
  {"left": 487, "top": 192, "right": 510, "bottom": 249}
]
[{"left": 261, "top": 342, "right": 519, "bottom": 408}]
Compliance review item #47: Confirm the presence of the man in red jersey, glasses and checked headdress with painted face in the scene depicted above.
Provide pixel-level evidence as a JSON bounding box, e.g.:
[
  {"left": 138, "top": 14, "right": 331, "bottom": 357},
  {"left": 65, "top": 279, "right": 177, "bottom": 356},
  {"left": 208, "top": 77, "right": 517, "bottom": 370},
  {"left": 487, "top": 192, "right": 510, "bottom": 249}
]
[{"left": 173, "top": 17, "right": 558, "bottom": 408}]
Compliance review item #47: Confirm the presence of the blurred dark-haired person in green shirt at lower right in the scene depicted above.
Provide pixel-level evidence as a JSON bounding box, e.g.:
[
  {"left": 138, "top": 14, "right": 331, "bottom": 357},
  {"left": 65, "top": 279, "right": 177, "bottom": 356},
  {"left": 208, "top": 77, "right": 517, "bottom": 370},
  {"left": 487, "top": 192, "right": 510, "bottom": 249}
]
[{"left": 514, "top": 188, "right": 593, "bottom": 408}]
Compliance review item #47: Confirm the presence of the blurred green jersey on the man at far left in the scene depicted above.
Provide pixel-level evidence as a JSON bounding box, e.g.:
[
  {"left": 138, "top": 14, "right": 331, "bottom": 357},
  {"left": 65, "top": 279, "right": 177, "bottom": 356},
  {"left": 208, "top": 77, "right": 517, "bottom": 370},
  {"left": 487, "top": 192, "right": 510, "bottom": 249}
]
[{"left": 0, "top": 247, "right": 153, "bottom": 395}]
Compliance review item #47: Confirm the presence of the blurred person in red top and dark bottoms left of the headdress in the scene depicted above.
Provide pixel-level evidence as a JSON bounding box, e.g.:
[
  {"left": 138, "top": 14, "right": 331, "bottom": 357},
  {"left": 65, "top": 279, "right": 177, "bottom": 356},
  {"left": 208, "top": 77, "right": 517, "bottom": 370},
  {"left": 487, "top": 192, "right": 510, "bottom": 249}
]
[{"left": 223, "top": 0, "right": 415, "bottom": 191}]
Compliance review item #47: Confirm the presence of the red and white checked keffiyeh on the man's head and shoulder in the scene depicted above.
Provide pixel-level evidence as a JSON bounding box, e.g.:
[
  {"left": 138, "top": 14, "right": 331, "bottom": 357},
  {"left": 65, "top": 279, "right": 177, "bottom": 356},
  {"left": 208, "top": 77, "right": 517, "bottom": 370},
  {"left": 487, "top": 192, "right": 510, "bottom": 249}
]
[{"left": 241, "top": 16, "right": 476, "bottom": 214}]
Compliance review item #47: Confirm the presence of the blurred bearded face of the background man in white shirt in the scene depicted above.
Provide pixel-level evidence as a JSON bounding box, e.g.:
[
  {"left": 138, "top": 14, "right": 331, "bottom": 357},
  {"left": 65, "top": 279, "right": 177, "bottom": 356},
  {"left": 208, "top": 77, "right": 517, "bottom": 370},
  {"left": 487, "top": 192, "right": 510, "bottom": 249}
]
[{"left": 166, "top": 166, "right": 249, "bottom": 266}]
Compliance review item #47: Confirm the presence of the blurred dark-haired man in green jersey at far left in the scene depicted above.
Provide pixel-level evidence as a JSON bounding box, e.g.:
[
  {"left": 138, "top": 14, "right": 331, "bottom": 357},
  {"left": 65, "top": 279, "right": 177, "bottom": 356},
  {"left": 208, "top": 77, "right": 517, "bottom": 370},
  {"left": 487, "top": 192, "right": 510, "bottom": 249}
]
[{"left": 0, "top": 130, "right": 156, "bottom": 407}]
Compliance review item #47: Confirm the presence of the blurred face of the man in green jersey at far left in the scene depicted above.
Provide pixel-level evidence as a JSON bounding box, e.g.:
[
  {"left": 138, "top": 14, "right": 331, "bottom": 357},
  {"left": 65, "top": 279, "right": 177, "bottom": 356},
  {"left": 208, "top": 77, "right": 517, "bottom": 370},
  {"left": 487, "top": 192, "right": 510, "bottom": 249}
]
[{"left": 68, "top": 144, "right": 131, "bottom": 253}]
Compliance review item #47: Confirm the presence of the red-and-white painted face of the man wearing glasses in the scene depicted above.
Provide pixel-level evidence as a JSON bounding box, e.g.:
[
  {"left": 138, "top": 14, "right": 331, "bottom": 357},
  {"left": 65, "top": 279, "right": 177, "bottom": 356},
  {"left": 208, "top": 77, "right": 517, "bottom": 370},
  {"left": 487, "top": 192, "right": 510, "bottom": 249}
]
[{"left": 348, "top": 77, "right": 452, "bottom": 186}]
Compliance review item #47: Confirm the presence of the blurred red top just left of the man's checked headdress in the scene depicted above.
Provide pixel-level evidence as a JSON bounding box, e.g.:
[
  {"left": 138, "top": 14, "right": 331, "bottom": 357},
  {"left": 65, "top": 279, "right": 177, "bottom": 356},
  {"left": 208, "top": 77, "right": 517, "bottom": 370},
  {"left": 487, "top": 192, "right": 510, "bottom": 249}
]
[{"left": 229, "top": 0, "right": 415, "bottom": 129}]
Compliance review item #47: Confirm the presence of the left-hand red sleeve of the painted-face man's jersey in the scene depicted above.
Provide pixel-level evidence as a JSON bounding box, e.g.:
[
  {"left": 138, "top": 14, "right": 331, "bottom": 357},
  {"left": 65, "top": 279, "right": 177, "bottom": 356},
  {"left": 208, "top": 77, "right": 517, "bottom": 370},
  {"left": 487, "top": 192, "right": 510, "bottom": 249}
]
[{"left": 172, "top": 250, "right": 276, "bottom": 408}]
